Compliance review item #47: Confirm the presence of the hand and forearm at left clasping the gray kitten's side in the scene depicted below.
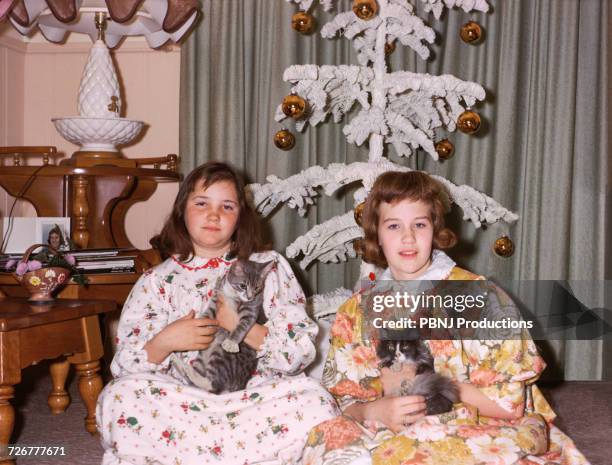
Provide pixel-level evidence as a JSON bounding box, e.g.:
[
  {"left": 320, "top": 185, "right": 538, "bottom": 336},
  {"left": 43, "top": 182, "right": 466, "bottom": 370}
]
[{"left": 144, "top": 310, "right": 219, "bottom": 363}]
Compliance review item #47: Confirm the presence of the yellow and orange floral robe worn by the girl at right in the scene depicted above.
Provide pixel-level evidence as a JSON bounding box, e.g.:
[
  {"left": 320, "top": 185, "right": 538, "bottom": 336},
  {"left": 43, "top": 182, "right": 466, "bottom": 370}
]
[{"left": 303, "top": 267, "right": 588, "bottom": 465}]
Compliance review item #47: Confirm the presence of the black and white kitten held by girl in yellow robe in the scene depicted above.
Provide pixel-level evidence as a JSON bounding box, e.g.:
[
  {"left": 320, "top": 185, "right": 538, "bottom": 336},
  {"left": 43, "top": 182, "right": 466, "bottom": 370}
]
[{"left": 376, "top": 330, "right": 459, "bottom": 415}]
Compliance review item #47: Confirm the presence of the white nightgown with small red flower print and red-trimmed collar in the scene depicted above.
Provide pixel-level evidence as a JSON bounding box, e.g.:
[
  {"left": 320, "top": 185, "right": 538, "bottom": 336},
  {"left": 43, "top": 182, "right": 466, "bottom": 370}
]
[{"left": 96, "top": 251, "right": 338, "bottom": 465}]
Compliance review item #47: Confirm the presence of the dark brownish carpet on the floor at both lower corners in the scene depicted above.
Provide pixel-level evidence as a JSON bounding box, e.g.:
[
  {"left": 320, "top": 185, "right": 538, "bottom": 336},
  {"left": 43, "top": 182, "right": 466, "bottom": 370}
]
[{"left": 12, "top": 363, "right": 612, "bottom": 465}]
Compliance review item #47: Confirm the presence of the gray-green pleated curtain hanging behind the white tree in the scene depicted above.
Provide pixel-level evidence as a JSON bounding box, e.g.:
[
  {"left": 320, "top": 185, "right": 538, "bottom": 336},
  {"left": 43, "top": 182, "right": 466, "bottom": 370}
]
[{"left": 180, "top": 0, "right": 612, "bottom": 379}]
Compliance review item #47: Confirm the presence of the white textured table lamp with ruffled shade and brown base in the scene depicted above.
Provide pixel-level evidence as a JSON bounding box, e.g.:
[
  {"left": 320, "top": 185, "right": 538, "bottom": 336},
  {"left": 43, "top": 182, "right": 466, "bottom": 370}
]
[{"left": 0, "top": 0, "right": 200, "bottom": 165}]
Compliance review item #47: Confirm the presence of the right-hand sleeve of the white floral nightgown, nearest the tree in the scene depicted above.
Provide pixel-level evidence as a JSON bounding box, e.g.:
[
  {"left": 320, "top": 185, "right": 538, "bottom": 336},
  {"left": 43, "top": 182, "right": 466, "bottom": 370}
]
[{"left": 251, "top": 251, "right": 319, "bottom": 374}]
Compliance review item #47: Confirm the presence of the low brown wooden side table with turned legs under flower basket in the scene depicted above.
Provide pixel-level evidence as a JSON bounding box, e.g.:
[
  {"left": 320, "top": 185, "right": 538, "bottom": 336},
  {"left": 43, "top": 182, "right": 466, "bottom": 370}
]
[{"left": 0, "top": 297, "right": 117, "bottom": 464}]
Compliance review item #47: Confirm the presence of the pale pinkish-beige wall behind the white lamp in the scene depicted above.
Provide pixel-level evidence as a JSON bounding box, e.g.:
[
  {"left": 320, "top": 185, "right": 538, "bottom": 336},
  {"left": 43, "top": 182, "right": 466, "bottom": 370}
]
[{"left": 0, "top": 24, "right": 180, "bottom": 248}]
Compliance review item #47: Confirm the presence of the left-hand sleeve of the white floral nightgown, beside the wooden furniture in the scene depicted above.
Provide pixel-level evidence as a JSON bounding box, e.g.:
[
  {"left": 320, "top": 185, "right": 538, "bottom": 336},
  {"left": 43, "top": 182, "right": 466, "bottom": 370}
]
[{"left": 111, "top": 269, "right": 170, "bottom": 377}]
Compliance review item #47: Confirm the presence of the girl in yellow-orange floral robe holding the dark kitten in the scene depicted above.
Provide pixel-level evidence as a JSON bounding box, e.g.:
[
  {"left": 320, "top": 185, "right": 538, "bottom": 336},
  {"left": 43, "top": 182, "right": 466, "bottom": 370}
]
[{"left": 304, "top": 172, "right": 588, "bottom": 465}]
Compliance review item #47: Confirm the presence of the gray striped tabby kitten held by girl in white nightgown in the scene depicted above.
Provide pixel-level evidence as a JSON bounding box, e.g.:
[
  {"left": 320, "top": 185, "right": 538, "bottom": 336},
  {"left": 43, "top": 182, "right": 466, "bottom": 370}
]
[{"left": 172, "top": 259, "right": 276, "bottom": 394}]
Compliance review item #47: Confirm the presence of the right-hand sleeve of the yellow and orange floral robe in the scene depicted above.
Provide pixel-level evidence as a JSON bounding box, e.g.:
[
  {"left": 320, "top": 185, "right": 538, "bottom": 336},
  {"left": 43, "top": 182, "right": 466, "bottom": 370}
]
[{"left": 463, "top": 287, "right": 546, "bottom": 415}]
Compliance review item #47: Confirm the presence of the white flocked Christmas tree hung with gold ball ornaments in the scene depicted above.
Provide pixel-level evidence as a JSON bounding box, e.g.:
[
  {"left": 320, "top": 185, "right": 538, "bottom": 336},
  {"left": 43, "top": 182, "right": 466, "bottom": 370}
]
[{"left": 250, "top": 0, "right": 518, "bottom": 317}]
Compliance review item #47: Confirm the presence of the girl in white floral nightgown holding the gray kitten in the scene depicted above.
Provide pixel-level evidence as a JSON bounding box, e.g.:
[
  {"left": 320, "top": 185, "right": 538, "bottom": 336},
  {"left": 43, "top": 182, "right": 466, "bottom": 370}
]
[{"left": 96, "top": 162, "right": 338, "bottom": 465}]
